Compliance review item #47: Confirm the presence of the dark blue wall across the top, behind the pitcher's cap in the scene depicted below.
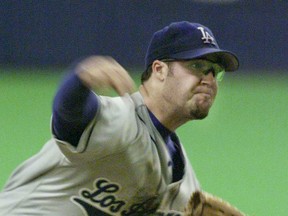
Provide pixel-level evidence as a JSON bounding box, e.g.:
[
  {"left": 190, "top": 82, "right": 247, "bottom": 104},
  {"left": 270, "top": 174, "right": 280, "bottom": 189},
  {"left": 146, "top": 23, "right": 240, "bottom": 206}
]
[{"left": 0, "top": 0, "right": 288, "bottom": 69}]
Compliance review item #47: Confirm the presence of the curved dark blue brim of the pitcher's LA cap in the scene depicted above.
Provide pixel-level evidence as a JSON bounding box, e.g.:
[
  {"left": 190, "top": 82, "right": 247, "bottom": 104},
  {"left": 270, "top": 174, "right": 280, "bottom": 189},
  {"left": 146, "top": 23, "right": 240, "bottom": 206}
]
[{"left": 169, "top": 48, "right": 239, "bottom": 72}]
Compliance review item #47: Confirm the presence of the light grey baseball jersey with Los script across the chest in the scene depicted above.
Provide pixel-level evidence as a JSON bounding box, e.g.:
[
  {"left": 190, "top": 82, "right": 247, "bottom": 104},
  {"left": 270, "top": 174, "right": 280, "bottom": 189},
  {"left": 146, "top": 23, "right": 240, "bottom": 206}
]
[{"left": 0, "top": 92, "right": 200, "bottom": 216}]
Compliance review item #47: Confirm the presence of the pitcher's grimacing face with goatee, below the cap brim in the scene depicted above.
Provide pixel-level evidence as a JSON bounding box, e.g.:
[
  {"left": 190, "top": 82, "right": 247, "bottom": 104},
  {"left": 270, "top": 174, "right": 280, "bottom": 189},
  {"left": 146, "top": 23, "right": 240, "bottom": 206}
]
[{"left": 163, "top": 60, "right": 218, "bottom": 120}]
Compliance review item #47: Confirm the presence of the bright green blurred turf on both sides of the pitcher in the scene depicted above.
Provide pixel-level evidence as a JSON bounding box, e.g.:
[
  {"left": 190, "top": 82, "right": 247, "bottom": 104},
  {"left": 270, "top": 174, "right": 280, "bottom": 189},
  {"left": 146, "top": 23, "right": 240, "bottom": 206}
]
[{"left": 0, "top": 69, "right": 288, "bottom": 216}]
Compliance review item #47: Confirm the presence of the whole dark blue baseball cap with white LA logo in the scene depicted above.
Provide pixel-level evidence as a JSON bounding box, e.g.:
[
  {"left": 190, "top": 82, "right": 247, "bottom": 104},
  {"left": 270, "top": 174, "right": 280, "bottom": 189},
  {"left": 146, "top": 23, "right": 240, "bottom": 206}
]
[{"left": 145, "top": 21, "right": 239, "bottom": 71}]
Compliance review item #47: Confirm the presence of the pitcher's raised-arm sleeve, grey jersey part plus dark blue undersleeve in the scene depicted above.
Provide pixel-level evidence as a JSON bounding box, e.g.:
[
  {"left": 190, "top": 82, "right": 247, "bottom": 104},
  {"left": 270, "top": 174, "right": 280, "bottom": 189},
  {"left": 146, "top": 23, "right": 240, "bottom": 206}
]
[{"left": 51, "top": 73, "right": 138, "bottom": 161}]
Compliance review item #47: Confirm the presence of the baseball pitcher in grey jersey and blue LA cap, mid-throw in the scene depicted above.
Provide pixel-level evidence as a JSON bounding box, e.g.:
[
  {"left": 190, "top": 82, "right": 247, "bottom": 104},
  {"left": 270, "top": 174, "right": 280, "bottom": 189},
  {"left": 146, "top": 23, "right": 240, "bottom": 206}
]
[{"left": 0, "top": 21, "right": 243, "bottom": 216}]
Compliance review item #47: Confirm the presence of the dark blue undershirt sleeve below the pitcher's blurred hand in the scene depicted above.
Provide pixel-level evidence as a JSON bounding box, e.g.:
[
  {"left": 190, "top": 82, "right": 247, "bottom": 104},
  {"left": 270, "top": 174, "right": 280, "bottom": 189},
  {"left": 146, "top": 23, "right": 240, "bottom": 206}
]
[{"left": 52, "top": 72, "right": 99, "bottom": 147}]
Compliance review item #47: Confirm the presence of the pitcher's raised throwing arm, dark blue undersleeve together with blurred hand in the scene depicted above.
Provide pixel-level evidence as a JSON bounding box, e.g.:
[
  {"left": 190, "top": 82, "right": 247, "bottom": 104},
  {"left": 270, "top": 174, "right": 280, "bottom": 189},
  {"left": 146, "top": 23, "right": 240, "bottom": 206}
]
[{"left": 52, "top": 56, "right": 135, "bottom": 146}]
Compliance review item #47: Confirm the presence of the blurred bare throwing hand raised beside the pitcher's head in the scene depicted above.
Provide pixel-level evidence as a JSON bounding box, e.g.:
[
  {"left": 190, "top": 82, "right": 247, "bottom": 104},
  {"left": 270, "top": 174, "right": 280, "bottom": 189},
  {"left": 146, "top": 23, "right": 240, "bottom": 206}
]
[{"left": 76, "top": 56, "right": 135, "bottom": 95}]
